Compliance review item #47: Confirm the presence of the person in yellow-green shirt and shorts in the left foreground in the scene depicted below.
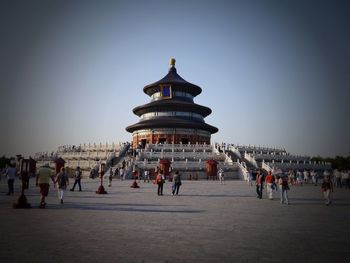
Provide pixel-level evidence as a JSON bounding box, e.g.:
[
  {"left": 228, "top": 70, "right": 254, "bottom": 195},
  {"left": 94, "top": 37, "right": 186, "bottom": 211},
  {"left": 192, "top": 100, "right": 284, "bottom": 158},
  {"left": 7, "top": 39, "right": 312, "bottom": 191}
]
[{"left": 36, "top": 163, "right": 55, "bottom": 208}]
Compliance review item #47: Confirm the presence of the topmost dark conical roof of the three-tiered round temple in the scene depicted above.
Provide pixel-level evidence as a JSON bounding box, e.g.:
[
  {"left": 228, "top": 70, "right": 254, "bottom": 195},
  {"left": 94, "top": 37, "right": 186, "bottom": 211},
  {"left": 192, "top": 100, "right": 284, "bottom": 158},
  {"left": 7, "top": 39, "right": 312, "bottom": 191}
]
[{"left": 143, "top": 65, "right": 202, "bottom": 97}]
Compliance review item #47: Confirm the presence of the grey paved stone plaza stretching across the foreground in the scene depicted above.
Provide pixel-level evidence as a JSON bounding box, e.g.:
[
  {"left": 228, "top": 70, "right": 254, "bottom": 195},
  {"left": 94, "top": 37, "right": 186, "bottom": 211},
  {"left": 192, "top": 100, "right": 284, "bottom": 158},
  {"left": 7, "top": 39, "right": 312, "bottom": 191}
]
[{"left": 0, "top": 178, "right": 350, "bottom": 263}]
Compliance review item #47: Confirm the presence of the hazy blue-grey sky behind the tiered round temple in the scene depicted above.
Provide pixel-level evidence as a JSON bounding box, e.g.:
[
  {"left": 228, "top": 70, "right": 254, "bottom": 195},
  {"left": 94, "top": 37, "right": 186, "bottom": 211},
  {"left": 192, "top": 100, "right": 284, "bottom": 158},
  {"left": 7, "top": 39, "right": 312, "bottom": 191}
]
[{"left": 0, "top": 0, "right": 350, "bottom": 159}]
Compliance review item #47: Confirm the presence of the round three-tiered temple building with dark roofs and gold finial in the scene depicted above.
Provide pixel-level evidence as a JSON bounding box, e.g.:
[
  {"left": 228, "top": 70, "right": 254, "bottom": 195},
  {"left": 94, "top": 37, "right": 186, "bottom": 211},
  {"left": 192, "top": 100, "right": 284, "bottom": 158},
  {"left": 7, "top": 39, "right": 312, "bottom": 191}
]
[{"left": 126, "top": 58, "right": 218, "bottom": 148}]
